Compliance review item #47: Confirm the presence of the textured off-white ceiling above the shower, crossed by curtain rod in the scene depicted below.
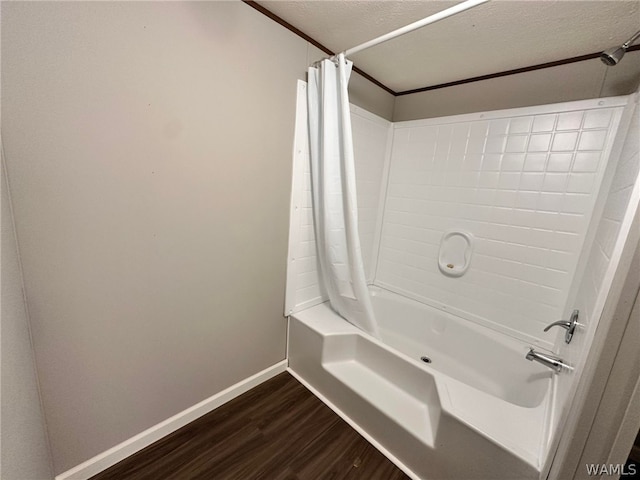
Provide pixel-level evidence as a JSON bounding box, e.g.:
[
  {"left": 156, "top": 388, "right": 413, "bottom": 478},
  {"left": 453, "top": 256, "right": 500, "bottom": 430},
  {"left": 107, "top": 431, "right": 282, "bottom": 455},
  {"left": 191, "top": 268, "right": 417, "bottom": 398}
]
[{"left": 259, "top": 0, "right": 640, "bottom": 92}]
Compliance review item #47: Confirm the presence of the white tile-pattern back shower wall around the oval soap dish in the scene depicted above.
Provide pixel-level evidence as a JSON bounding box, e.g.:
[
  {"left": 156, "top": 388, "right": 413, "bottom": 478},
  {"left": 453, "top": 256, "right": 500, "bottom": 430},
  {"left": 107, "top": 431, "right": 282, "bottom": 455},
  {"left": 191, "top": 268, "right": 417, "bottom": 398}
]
[{"left": 375, "top": 99, "right": 622, "bottom": 347}]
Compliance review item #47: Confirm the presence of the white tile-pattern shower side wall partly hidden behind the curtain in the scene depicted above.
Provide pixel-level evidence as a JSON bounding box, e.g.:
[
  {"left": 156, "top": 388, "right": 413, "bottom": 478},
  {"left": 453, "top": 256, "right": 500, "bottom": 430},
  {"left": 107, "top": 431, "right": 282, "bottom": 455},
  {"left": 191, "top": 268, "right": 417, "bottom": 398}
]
[{"left": 285, "top": 99, "right": 392, "bottom": 314}]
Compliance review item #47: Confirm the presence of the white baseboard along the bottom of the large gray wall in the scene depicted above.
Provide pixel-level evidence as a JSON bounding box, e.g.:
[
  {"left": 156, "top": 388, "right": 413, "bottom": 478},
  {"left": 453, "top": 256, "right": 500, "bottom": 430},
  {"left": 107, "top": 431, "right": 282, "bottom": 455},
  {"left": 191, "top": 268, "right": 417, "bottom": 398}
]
[{"left": 55, "top": 360, "right": 287, "bottom": 480}]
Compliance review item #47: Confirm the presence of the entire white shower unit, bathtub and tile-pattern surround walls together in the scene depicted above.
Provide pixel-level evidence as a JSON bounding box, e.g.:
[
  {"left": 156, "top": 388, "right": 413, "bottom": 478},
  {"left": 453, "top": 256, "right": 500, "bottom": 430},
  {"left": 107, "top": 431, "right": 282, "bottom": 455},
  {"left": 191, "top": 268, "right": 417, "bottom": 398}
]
[{"left": 285, "top": 82, "right": 637, "bottom": 479}]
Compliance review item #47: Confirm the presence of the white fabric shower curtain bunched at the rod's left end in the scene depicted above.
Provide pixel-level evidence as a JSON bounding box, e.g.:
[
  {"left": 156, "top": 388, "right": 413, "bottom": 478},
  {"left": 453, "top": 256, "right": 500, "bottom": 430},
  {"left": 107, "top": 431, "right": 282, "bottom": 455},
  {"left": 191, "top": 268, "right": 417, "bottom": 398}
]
[{"left": 308, "top": 54, "right": 379, "bottom": 337}]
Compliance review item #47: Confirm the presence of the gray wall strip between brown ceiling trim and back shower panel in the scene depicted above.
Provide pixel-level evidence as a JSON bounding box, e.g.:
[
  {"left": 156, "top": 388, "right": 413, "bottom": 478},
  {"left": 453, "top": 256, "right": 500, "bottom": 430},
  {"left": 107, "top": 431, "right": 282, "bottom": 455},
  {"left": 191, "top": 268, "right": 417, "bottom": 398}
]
[{"left": 393, "top": 51, "right": 640, "bottom": 122}]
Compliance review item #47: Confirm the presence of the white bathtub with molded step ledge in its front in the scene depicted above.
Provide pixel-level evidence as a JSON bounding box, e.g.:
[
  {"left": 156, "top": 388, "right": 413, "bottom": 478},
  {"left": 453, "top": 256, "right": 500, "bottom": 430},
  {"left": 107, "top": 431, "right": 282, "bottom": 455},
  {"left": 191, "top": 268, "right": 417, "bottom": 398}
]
[{"left": 288, "top": 287, "right": 555, "bottom": 480}]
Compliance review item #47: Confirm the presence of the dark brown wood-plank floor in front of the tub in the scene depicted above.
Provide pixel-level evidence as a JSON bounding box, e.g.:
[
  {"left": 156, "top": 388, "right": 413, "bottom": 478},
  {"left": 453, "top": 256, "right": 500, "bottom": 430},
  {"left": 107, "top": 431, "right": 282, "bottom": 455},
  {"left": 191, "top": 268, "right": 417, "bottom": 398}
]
[{"left": 92, "top": 373, "right": 409, "bottom": 480}]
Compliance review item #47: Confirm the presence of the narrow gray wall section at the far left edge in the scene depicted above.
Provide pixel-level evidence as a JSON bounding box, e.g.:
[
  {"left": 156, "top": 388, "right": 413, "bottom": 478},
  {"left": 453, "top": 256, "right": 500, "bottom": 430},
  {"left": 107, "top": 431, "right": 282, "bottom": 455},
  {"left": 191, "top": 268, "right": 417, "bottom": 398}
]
[{"left": 0, "top": 154, "right": 53, "bottom": 480}]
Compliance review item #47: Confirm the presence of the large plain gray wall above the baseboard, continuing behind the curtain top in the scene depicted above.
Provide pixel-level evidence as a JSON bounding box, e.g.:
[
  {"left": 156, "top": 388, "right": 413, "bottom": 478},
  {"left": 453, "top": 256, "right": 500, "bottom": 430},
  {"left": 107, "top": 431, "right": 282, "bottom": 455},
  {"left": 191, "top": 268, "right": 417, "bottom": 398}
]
[{"left": 2, "top": 2, "right": 393, "bottom": 473}]
